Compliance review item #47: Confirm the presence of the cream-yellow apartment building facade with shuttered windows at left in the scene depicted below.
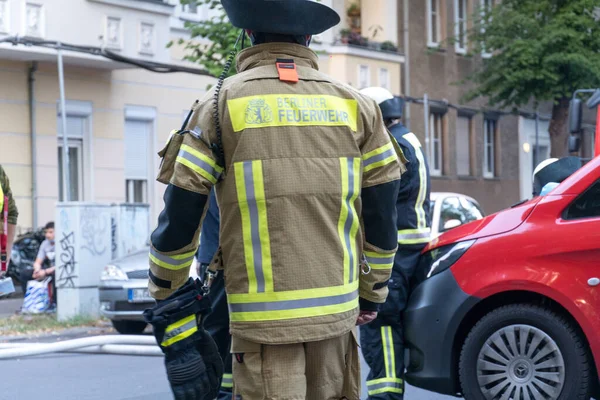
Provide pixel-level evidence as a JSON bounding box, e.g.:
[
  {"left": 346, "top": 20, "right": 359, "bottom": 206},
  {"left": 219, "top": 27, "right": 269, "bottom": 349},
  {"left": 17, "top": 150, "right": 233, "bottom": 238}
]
[{"left": 0, "top": 0, "right": 404, "bottom": 232}]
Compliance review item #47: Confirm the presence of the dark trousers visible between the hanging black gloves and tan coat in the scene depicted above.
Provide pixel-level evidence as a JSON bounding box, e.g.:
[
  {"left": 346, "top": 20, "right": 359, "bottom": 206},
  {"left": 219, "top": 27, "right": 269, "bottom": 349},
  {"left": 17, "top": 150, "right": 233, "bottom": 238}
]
[{"left": 200, "top": 265, "right": 233, "bottom": 400}]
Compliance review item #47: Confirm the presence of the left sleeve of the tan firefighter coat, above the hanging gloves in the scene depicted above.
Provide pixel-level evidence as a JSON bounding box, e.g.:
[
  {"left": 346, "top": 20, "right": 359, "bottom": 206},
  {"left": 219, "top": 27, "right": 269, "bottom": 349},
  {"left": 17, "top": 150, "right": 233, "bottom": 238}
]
[{"left": 148, "top": 91, "right": 223, "bottom": 300}]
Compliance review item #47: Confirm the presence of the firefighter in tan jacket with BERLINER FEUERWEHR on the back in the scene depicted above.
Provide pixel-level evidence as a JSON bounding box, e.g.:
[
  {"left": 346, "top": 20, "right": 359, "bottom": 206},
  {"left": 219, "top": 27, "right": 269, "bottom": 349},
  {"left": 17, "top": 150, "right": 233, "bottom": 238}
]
[{"left": 145, "top": 0, "right": 405, "bottom": 400}]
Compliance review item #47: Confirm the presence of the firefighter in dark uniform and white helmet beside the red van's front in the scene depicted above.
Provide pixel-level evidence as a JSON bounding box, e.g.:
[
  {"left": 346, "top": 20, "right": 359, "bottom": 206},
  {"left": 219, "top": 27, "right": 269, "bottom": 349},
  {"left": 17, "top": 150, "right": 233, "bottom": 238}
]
[{"left": 360, "top": 88, "right": 431, "bottom": 400}]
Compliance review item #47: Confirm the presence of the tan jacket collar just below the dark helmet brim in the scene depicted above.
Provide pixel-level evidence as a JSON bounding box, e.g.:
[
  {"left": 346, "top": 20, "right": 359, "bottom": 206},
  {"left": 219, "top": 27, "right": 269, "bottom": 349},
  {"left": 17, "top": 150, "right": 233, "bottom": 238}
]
[{"left": 236, "top": 43, "right": 319, "bottom": 72}]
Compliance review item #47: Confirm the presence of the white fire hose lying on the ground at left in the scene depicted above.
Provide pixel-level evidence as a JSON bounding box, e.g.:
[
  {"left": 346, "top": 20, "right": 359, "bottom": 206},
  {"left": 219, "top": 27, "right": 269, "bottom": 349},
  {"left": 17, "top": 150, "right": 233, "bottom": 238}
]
[{"left": 0, "top": 335, "right": 163, "bottom": 360}]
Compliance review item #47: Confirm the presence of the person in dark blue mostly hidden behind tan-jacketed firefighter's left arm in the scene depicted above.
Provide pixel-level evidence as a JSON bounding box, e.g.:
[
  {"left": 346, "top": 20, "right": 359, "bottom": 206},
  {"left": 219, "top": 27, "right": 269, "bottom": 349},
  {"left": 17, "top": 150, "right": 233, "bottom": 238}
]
[{"left": 196, "top": 188, "right": 233, "bottom": 400}]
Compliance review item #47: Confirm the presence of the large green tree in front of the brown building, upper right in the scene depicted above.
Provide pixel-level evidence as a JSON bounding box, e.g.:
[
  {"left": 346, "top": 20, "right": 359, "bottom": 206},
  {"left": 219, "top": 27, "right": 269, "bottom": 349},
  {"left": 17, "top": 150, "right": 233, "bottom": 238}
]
[{"left": 466, "top": 0, "right": 600, "bottom": 157}]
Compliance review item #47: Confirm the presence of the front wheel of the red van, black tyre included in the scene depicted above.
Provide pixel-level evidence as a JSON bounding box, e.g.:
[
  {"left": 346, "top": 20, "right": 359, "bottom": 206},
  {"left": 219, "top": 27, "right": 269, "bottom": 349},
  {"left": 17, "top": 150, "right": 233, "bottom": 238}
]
[{"left": 459, "top": 304, "right": 591, "bottom": 400}]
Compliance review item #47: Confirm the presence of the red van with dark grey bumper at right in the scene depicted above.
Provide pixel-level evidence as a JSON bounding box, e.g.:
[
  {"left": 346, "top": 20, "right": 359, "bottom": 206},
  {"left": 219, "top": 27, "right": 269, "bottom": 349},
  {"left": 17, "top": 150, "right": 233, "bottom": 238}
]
[{"left": 404, "top": 157, "right": 600, "bottom": 400}]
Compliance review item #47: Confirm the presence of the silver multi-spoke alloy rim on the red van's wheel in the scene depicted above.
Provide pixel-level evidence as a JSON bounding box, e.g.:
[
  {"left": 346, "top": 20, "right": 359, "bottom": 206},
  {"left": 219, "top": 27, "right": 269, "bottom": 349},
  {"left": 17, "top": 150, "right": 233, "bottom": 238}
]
[{"left": 477, "top": 325, "right": 565, "bottom": 400}]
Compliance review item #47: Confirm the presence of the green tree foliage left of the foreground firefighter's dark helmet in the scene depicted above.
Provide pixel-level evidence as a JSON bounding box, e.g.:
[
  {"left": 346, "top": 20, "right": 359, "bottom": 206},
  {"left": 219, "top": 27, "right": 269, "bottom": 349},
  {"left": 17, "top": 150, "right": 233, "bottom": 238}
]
[{"left": 169, "top": 0, "right": 240, "bottom": 77}]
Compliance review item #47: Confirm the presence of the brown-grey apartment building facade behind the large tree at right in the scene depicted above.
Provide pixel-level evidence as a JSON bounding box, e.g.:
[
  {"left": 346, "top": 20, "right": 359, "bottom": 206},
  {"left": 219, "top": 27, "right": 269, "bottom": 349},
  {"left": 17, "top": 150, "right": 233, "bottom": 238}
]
[{"left": 398, "top": 0, "right": 593, "bottom": 213}]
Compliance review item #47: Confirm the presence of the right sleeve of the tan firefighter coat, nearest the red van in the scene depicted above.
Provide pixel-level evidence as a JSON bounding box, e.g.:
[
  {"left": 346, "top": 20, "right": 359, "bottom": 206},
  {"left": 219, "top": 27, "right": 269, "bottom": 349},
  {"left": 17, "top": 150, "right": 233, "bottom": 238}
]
[{"left": 359, "top": 96, "right": 406, "bottom": 311}]
